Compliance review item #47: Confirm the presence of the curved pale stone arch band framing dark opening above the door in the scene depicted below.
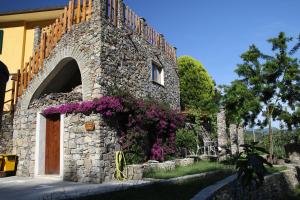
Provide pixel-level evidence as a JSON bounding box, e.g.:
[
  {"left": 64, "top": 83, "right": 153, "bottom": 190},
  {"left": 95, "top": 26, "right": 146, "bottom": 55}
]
[{"left": 20, "top": 47, "right": 93, "bottom": 110}]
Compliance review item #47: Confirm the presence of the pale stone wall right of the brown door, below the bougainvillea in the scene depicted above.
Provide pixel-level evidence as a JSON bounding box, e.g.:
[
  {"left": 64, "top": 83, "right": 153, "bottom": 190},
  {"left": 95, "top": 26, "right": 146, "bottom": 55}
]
[{"left": 64, "top": 114, "right": 117, "bottom": 183}]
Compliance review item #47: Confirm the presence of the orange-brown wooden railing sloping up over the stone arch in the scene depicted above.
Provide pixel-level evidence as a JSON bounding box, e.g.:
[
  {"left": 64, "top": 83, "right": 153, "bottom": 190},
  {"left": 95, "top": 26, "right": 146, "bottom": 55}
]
[{"left": 17, "top": 0, "right": 92, "bottom": 96}]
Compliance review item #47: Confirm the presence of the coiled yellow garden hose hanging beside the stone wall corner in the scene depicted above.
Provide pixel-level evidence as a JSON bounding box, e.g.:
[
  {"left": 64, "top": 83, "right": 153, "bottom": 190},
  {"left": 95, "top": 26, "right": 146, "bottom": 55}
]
[{"left": 114, "top": 151, "right": 127, "bottom": 181}]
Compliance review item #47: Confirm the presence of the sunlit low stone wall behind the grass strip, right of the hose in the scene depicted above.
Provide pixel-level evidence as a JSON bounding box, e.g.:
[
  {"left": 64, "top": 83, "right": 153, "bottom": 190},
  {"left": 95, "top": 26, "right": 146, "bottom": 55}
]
[{"left": 127, "top": 158, "right": 194, "bottom": 180}]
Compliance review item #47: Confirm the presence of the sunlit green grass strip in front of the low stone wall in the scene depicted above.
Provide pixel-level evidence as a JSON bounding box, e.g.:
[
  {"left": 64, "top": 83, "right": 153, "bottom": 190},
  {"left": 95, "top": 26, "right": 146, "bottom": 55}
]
[{"left": 144, "top": 161, "right": 234, "bottom": 179}]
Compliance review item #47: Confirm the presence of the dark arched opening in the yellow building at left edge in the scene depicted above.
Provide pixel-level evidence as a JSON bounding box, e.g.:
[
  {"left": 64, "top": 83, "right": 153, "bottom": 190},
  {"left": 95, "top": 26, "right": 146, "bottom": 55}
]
[{"left": 0, "top": 61, "right": 9, "bottom": 127}]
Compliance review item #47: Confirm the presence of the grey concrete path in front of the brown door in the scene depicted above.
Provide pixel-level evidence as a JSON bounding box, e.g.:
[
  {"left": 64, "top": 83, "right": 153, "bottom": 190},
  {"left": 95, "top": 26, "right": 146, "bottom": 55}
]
[{"left": 0, "top": 177, "right": 149, "bottom": 200}]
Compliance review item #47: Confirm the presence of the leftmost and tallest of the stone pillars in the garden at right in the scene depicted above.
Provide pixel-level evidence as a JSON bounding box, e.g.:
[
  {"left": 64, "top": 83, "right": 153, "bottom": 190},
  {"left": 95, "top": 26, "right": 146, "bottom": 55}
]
[{"left": 217, "top": 109, "right": 228, "bottom": 153}]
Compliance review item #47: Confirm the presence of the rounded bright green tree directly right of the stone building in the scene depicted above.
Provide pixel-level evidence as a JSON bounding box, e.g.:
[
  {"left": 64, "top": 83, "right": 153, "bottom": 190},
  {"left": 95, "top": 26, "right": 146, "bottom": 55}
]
[{"left": 178, "top": 56, "right": 215, "bottom": 111}]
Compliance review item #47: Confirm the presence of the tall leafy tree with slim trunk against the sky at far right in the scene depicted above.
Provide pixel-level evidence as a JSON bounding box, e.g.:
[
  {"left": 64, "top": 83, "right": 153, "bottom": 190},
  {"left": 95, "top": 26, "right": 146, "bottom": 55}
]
[{"left": 236, "top": 32, "right": 300, "bottom": 160}]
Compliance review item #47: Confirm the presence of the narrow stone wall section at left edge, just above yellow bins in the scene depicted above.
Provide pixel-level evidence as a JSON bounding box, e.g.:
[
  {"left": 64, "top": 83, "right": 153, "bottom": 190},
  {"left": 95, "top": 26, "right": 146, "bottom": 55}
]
[{"left": 0, "top": 113, "right": 13, "bottom": 154}]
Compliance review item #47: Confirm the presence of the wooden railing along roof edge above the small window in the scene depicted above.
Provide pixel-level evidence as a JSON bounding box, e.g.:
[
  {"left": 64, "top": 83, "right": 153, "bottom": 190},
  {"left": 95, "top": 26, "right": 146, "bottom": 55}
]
[{"left": 107, "top": 0, "right": 177, "bottom": 61}]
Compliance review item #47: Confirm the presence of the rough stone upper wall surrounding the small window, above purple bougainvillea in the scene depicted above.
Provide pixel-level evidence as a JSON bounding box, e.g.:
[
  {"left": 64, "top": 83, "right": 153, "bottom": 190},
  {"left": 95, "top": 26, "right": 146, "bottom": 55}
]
[{"left": 98, "top": 1, "right": 180, "bottom": 110}]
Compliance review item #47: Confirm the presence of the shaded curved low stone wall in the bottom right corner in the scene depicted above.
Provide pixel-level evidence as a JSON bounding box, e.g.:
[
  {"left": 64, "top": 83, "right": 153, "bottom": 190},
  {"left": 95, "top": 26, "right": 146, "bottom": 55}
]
[{"left": 193, "top": 165, "right": 300, "bottom": 200}]
